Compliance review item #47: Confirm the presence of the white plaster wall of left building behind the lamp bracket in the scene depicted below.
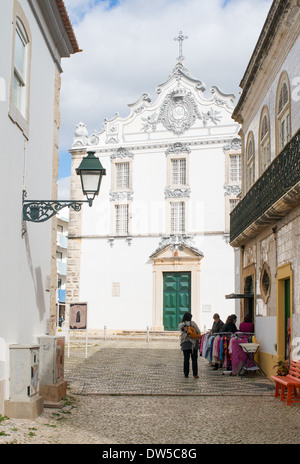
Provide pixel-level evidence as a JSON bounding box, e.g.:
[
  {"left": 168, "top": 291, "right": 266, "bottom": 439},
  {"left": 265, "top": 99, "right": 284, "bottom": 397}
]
[{"left": 0, "top": 0, "right": 54, "bottom": 413}]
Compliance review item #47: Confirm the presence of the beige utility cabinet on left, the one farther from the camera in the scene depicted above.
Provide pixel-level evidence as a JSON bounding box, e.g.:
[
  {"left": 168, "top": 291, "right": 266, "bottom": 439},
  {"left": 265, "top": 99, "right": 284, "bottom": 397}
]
[{"left": 38, "top": 335, "right": 65, "bottom": 385}]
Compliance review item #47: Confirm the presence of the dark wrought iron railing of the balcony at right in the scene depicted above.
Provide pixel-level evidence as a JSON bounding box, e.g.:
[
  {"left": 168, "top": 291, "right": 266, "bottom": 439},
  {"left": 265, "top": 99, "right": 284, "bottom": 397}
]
[{"left": 230, "top": 130, "right": 300, "bottom": 244}]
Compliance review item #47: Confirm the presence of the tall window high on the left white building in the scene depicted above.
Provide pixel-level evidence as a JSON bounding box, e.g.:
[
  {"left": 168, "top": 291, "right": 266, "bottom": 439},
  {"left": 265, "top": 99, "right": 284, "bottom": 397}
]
[{"left": 12, "top": 18, "right": 29, "bottom": 118}]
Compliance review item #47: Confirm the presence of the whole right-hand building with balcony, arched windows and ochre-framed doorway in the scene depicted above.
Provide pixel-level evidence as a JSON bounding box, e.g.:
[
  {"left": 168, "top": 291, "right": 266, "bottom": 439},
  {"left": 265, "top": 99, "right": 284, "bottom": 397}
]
[{"left": 230, "top": 0, "right": 300, "bottom": 374}]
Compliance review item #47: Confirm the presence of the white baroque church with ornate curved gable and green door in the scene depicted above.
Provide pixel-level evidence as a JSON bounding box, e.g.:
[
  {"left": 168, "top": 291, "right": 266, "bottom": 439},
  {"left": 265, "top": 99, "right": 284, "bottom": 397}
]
[{"left": 66, "top": 43, "right": 241, "bottom": 333}]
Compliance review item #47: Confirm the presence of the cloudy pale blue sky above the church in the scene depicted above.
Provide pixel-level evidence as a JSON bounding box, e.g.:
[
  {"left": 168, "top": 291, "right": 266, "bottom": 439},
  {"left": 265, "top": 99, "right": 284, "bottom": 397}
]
[{"left": 59, "top": 0, "right": 272, "bottom": 199}]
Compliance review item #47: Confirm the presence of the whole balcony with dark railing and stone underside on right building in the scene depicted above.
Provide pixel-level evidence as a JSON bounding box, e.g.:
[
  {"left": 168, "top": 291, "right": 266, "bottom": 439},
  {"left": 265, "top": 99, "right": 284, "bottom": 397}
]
[{"left": 230, "top": 131, "right": 300, "bottom": 246}]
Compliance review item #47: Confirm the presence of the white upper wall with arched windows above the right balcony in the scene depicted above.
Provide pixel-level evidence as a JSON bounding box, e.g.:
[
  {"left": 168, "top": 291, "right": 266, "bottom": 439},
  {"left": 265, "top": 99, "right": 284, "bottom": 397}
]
[{"left": 243, "top": 32, "right": 300, "bottom": 194}]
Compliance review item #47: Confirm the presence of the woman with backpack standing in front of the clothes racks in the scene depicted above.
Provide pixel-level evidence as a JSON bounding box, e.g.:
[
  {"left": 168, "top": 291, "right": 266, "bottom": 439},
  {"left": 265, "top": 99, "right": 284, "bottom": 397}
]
[{"left": 179, "top": 312, "right": 201, "bottom": 379}]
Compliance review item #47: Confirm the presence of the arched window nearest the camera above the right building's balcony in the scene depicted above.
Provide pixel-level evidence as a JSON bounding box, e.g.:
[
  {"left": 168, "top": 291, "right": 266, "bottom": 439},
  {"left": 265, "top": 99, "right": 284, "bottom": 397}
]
[{"left": 277, "top": 73, "right": 291, "bottom": 152}]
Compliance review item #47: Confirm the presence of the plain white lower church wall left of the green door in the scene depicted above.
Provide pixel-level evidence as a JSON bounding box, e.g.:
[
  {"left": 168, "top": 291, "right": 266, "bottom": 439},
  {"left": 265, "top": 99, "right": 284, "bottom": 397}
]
[{"left": 80, "top": 238, "right": 157, "bottom": 330}]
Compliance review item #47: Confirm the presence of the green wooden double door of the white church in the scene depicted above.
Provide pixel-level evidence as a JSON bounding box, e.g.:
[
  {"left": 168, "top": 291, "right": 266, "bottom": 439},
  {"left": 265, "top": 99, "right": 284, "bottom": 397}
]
[{"left": 163, "top": 272, "right": 191, "bottom": 330}]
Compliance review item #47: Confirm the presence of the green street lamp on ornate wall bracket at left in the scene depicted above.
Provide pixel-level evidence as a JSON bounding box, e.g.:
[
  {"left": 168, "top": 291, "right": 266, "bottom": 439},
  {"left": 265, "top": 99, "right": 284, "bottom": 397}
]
[{"left": 23, "top": 151, "right": 106, "bottom": 226}]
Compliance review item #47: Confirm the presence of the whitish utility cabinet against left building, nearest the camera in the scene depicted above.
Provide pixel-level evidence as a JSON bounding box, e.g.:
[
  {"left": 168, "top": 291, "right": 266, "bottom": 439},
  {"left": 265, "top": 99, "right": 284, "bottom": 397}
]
[{"left": 9, "top": 344, "right": 40, "bottom": 401}]
